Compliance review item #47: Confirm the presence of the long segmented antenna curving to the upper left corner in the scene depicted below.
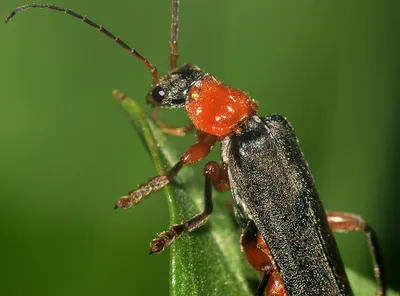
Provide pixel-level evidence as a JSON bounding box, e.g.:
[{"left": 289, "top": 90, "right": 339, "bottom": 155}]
[{"left": 5, "top": 3, "right": 158, "bottom": 84}]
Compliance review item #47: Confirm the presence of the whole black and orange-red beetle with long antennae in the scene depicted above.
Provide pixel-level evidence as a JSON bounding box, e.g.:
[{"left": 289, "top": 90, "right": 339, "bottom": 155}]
[{"left": 6, "top": 0, "right": 386, "bottom": 296}]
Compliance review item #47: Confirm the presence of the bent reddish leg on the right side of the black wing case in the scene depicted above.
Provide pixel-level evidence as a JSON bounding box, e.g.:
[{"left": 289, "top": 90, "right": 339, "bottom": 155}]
[{"left": 326, "top": 212, "right": 386, "bottom": 296}]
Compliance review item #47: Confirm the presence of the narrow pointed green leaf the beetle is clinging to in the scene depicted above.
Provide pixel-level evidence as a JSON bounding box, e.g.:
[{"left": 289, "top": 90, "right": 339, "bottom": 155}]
[{"left": 120, "top": 98, "right": 400, "bottom": 296}]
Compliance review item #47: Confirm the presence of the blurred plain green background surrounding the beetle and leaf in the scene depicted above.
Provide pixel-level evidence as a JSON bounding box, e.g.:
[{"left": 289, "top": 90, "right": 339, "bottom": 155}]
[{"left": 0, "top": 0, "right": 400, "bottom": 295}]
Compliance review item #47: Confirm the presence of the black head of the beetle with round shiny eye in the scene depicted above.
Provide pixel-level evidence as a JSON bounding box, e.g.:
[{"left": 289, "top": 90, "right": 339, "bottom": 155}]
[{"left": 147, "top": 65, "right": 206, "bottom": 108}]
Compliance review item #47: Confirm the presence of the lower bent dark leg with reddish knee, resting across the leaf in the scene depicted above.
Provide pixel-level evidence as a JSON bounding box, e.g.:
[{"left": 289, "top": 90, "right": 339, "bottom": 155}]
[{"left": 150, "top": 162, "right": 220, "bottom": 254}]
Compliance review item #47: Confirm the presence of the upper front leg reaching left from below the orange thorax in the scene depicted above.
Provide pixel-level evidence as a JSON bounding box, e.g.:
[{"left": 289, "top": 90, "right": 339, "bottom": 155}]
[{"left": 114, "top": 131, "right": 216, "bottom": 209}]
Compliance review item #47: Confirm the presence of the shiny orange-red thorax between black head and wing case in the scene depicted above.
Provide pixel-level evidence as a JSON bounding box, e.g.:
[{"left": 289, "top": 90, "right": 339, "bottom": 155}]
[{"left": 185, "top": 76, "right": 257, "bottom": 136}]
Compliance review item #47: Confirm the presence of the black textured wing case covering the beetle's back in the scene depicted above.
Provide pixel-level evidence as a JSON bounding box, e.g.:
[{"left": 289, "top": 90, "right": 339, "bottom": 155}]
[{"left": 221, "top": 115, "right": 352, "bottom": 296}]
